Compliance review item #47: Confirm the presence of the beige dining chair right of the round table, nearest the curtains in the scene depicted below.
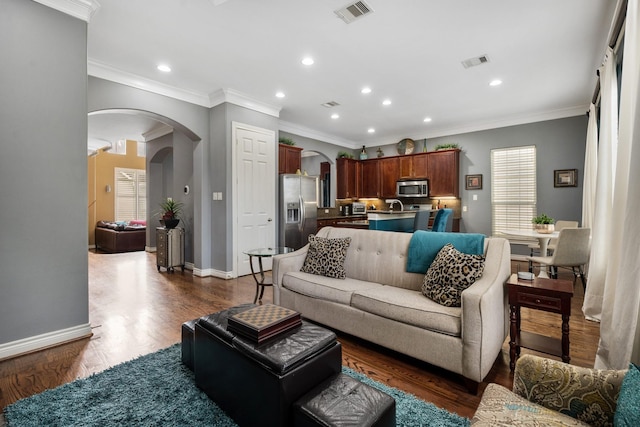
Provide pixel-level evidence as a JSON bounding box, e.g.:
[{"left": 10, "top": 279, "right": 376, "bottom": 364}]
[{"left": 527, "top": 228, "right": 591, "bottom": 290}]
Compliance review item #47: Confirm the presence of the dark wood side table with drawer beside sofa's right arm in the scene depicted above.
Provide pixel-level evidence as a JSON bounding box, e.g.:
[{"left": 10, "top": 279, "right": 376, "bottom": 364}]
[{"left": 507, "top": 274, "right": 573, "bottom": 371}]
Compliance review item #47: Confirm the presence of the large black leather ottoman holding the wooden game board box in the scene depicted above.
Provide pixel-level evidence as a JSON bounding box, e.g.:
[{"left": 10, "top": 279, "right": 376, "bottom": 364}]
[{"left": 194, "top": 311, "right": 342, "bottom": 426}]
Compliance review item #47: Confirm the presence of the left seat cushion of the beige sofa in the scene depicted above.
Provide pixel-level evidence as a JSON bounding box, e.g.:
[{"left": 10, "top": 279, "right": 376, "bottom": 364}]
[{"left": 282, "top": 271, "right": 382, "bottom": 305}]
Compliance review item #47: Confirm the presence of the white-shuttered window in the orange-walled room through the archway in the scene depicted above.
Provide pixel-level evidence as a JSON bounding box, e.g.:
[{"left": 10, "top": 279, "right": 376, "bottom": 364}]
[{"left": 115, "top": 168, "right": 147, "bottom": 221}]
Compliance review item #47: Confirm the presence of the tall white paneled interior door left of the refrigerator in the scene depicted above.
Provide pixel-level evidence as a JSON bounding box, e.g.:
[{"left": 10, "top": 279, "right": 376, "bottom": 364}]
[{"left": 233, "top": 123, "right": 276, "bottom": 276}]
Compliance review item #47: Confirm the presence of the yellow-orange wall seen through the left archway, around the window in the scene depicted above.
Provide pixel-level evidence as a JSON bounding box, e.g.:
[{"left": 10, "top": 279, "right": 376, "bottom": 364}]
[{"left": 87, "top": 141, "right": 146, "bottom": 247}]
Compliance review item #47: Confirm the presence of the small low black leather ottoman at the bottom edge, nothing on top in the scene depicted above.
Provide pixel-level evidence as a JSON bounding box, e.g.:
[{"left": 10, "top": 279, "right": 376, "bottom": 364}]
[{"left": 293, "top": 373, "right": 396, "bottom": 427}]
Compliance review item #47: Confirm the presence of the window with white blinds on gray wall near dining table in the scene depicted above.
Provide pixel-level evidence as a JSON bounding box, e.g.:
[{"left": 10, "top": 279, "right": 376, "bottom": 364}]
[{"left": 491, "top": 146, "right": 536, "bottom": 235}]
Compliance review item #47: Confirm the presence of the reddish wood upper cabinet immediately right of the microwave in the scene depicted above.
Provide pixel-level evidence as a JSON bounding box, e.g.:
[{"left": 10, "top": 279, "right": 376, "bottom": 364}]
[{"left": 427, "top": 150, "right": 460, "bottom": 198}]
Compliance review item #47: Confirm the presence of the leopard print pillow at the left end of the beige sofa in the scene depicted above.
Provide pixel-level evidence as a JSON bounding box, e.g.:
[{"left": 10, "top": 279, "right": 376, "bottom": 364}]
[{"left": 300, "top": 234, "right": 351, "bottom": 279}]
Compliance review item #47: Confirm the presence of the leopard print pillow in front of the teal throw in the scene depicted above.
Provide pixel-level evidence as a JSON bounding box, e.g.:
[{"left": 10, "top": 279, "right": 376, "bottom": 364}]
[{"left": 422, "top": 243, "right": 484, "bottom": 307}]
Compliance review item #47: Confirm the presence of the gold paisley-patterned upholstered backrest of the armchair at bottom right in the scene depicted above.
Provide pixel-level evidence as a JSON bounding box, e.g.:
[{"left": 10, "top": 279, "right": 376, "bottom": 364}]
[{"left": 513, "top": 354, "right": 627, "bottom": 426}]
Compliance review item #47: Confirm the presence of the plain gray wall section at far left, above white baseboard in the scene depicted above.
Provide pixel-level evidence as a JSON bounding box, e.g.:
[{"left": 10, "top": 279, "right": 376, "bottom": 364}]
[{"left": 0, "top": 0, "right": 89, "bottom": 344}]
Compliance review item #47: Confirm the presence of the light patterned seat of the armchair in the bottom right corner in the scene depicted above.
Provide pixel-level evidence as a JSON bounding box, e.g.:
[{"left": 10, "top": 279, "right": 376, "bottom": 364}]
[{"left": 471, "top": 383, "right": 589, "bottom": 427}]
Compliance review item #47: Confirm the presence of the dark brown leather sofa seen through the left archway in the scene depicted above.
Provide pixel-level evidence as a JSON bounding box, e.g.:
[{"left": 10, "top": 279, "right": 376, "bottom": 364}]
[{"left": 95, "top": 221, "right": 147, "bottom": 253}]
